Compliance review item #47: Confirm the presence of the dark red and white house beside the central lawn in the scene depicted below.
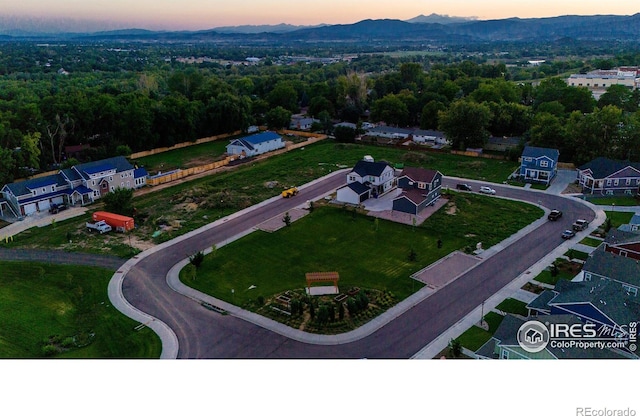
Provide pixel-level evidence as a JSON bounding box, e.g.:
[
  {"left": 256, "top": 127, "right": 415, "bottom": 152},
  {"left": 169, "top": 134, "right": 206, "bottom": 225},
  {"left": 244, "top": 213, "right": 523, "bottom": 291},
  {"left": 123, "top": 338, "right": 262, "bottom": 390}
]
[{"left": 393, "top": 167, "right": 442, "bottom": 215}]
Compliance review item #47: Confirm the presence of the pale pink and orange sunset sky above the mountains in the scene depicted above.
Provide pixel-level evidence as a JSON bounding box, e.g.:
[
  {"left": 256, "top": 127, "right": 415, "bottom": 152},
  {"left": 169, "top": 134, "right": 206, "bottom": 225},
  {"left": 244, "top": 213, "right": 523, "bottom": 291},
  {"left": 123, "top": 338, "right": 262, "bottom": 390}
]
[{"left": 0, "top": 0, "right": 640, "bottom": 30}]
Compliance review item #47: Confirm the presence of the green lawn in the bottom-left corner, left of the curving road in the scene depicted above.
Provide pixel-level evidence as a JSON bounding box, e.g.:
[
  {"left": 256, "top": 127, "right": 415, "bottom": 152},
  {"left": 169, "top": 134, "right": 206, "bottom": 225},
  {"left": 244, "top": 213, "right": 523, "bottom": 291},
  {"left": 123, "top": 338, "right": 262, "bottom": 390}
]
[{"left": 0, "top": 262, "right": 162, "bottom": 358}]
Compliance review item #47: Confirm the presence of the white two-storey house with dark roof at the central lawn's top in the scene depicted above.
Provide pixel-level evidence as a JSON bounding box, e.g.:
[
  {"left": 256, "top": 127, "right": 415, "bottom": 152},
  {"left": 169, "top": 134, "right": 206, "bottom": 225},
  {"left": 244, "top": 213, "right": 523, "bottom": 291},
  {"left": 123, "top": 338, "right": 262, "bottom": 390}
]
[{"left": 336, "top": 156, "right": 396, "bottom": 204}]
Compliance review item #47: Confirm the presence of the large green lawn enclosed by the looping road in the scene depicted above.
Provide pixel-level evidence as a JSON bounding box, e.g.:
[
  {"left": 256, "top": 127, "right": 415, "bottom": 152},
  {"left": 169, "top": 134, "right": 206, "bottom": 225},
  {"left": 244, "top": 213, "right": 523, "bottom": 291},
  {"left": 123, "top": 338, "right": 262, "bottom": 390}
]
[{"left": 181, "top": 193, "right": 543, "bottom": 306}]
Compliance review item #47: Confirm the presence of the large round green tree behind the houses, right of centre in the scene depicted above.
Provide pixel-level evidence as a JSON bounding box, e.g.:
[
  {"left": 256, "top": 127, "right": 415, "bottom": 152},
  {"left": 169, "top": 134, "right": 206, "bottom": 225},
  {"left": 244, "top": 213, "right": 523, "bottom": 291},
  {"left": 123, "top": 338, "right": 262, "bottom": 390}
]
[{"left": 438, "top": 100, "right": 491, "bottom": 150}]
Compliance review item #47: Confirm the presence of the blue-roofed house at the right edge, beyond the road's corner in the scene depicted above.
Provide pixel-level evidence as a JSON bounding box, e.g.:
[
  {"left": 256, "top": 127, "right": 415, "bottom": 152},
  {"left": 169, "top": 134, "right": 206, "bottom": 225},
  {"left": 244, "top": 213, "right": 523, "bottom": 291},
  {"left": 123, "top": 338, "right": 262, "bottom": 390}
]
[{"left": 578, "top": 157, "right": 640, "bottom": 195}]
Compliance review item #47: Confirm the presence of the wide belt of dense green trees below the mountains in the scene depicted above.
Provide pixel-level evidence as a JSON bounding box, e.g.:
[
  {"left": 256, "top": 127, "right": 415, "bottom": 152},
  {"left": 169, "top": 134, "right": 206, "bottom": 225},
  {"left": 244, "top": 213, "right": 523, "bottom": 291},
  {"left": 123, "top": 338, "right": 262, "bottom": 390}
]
[{"left": 0, "top": 45, "right": 640, "bottom": 183}]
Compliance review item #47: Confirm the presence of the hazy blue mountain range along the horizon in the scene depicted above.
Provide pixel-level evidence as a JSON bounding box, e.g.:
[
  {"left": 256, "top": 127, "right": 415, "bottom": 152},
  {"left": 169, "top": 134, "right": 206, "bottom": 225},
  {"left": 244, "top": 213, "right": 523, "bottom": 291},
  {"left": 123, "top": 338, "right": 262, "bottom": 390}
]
[{"left": 0, "top": 13, "right": 640, "bottom": 44}]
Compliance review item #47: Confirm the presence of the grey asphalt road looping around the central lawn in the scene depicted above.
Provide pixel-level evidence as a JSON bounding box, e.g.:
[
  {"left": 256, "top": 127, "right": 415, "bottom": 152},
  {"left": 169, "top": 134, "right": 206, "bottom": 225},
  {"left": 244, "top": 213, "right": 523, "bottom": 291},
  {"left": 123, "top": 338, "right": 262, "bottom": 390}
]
[{"left": 117, "top": 175, "right": 594, "bottom": 358}]
